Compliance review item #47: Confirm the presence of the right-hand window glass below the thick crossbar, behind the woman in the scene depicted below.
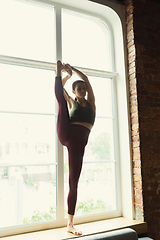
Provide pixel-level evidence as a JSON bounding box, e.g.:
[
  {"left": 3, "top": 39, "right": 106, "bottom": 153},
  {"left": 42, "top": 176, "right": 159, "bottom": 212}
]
[{"left": 64, "top": 76, "right": 117, "bottom": 216}]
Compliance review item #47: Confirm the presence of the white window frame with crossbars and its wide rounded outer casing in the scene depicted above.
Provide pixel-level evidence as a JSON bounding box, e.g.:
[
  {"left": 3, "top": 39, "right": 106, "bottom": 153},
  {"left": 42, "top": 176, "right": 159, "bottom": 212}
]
[{"left": 0, "top": 0, "right": 134, "bottom": 236}]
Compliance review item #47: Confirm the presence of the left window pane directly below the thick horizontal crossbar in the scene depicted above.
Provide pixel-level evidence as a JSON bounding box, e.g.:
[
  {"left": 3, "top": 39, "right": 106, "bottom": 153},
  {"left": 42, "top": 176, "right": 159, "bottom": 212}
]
[{"left": 0, "top": 64, "right": 55, "bottom": 113}]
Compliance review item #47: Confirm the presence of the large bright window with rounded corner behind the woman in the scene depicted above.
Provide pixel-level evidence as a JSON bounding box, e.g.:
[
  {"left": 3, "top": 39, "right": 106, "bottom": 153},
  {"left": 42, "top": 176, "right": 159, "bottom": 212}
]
[{"left": 0, "top": 0, "right": 129, "bottom": 236}]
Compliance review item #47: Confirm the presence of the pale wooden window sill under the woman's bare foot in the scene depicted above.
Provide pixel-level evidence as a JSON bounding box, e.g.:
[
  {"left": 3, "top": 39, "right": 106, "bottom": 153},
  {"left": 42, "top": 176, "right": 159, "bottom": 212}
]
[{"left": 1, "top": 217, "right": 147, "bottom": 240}]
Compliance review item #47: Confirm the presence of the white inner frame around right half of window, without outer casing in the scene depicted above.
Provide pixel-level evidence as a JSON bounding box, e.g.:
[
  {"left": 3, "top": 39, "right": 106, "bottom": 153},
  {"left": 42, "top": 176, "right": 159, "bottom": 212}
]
[{"left": 54, "top": 3, "right": 121, "bottom": 226}]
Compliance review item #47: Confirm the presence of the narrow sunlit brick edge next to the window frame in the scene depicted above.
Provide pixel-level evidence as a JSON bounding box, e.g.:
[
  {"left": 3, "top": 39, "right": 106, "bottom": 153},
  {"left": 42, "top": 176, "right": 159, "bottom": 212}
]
[{"left": 126, "top": 0, "right": 144, "bottom": 221}]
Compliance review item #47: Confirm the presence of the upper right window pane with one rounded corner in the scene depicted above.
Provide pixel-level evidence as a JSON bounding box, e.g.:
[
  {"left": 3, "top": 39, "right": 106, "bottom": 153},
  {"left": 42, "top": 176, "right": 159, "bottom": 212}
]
[{"left": 62, "top": 10, "right": 111, "bottom": 71}]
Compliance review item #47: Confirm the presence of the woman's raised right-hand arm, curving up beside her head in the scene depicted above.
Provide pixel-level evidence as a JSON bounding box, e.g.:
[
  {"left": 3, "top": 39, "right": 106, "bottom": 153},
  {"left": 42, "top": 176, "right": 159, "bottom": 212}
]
[{"left": 66, "top": 64, "right": 96, "bottom": 110}]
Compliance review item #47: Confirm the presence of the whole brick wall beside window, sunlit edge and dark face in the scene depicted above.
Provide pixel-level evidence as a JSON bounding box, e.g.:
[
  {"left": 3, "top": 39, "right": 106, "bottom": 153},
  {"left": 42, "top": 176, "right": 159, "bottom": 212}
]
[{"left": 126, "top": 0, "right": 160, "bottom": 240}]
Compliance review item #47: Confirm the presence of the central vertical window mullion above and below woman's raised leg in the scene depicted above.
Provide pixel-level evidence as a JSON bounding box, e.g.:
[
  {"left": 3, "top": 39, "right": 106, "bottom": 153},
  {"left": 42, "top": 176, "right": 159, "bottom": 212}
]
[{"left": 55, "top": 7, "right": 64, "bottom": 221}]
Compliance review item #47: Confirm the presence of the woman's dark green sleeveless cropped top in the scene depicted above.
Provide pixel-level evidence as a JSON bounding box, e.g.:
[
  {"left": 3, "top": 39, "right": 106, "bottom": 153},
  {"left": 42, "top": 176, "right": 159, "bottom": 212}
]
[{"left": 69, "top": 100, "right": 96, "bottom": 125}]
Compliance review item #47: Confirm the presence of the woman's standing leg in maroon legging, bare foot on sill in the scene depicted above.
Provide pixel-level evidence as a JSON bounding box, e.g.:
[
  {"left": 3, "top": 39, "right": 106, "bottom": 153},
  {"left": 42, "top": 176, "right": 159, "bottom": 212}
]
[{"left": 67, "top": 125, "right": 90, "bottom": 235}]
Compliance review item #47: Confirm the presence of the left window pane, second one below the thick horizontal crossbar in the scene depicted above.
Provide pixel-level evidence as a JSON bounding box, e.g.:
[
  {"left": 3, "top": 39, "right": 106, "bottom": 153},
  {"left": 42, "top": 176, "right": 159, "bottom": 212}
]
[{"left": 0, "top": 113, "right": 56, "bottom": 165}]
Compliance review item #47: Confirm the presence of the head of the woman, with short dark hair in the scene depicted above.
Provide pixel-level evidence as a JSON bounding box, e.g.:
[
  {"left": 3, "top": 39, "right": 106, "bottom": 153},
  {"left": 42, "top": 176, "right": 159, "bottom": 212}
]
[{"left": 72, "top": 80, "right": 86, "bottom": 98}]
